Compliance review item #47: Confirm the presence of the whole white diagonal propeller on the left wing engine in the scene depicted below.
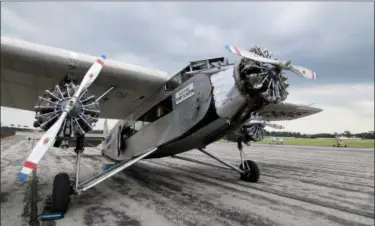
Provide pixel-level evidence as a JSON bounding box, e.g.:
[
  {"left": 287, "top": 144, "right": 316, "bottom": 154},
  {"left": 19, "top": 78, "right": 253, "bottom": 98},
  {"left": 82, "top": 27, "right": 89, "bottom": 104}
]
[{"left": 19, "top": 55, "right": 106, "bottom": 181}]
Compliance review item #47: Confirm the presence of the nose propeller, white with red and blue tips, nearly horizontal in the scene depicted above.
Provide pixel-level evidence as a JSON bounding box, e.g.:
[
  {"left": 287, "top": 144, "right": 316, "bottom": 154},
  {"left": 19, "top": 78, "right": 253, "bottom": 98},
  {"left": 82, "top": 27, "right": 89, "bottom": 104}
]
[{"left": 225, "top": 45, "right": 316, "bottom": 80}]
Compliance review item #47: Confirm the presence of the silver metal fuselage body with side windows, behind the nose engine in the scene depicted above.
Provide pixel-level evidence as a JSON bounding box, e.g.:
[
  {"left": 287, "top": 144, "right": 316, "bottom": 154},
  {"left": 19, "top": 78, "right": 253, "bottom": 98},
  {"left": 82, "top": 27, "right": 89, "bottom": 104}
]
[{"left": 103, "top": 66, "right": 246, "bottom": 160}]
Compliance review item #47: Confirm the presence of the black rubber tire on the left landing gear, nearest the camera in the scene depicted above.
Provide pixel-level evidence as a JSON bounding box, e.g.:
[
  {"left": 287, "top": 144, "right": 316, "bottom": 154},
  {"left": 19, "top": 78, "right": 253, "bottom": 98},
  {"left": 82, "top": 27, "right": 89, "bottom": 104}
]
[{"left": 51, "top": 173, "right": 71, "bottom": 214}]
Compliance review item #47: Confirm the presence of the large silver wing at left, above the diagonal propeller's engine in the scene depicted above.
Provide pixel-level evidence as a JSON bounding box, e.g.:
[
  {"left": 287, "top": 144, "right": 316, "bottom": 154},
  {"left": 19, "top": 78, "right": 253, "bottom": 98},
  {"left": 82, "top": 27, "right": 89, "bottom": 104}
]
[{"left": 1, "top": 36, "right": 168, "bottom": 119}]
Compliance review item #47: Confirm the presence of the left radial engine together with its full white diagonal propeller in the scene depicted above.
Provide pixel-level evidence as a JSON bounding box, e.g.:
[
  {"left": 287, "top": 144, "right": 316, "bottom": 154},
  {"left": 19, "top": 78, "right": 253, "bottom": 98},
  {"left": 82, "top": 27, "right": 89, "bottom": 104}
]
[{"left": 19, "top": 55, "right": 108, "bottom": 180}]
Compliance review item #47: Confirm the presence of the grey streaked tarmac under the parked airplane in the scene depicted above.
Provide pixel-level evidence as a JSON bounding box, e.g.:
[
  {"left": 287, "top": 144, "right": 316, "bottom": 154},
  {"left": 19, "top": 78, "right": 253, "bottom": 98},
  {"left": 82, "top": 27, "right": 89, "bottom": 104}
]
[{"left": 1, "top": 135, "right": 374, "bottom": 226}]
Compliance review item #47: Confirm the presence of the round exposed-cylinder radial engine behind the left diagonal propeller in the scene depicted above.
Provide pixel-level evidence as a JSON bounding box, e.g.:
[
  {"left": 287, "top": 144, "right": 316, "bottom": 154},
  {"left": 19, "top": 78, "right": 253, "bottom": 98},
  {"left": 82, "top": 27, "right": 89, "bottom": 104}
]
[{"left": 34, "top": 82, "right": 100, "bottom": 137}]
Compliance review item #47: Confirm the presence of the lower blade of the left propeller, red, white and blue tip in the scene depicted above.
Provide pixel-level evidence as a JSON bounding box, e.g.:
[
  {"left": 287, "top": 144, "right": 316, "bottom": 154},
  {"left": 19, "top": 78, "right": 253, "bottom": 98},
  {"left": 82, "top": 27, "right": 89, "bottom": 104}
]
[{"left": 18, "top": 112, "right": 68, "bottom": 181}]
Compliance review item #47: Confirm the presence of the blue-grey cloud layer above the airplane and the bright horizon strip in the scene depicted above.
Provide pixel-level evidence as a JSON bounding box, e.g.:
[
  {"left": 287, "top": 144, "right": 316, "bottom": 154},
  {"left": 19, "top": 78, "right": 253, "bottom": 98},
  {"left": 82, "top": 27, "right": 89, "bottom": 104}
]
[{"left": 1, "top": 2, "right": 374, "bottom": 84}]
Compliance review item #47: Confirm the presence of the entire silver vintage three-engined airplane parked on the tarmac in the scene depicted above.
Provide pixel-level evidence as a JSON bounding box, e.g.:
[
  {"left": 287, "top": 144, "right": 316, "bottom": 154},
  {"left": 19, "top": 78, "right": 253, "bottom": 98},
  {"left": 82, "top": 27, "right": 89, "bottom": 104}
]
[{"left": 1, "top": 37, "right": 321, "bottom": 213}]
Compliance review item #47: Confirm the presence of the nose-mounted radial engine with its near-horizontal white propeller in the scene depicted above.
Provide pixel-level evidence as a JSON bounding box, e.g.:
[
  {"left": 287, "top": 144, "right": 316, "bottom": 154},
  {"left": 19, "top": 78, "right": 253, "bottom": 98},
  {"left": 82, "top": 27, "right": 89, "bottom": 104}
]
[{"left": 226, "top": 45, "right": 316, "bottom": 132}]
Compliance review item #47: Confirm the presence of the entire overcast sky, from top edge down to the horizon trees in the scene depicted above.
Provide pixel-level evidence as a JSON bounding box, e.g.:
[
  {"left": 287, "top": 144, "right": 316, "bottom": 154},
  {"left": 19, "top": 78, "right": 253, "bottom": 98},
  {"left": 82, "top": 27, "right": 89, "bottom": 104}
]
[{"left": 1, "top": 2, "right": 374, "bottom": 133}]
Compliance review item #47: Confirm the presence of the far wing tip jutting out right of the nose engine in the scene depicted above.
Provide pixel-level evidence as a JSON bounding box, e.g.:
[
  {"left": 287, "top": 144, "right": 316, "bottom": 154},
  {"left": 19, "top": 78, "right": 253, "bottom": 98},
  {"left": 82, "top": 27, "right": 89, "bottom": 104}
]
[{"left": 258, "top": 103, "right": 323, "bottom": 121}]
